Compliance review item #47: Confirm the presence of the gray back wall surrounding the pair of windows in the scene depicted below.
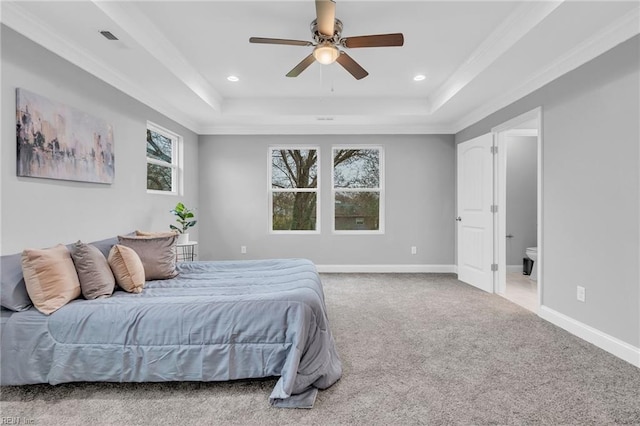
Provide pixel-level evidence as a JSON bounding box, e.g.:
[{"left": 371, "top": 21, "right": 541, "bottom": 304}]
[{"left": 199, "top": 135, "right": 455, "bottom": 265}]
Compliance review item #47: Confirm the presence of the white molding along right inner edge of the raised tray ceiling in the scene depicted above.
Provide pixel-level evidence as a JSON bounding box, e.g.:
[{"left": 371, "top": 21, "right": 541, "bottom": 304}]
[{"left": 428, "top": 0, "right": 564, "bottom": 113}]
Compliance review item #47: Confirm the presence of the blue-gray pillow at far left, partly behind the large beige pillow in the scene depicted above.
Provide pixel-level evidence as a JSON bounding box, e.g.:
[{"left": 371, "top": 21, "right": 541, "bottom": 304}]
[{"left": 0, "top": 253, "right": 32, "bottom": 312}]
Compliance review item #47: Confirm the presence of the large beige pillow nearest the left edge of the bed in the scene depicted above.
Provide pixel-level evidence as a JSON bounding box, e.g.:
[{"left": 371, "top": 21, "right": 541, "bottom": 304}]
[{"left": 22, "top": 244, "right": 80, "bottom": 315}]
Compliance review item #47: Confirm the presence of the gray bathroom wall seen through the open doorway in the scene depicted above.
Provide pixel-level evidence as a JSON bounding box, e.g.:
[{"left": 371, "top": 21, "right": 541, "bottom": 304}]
[{"left": 506, "top": 136, "right": 538, "bottom": 268}]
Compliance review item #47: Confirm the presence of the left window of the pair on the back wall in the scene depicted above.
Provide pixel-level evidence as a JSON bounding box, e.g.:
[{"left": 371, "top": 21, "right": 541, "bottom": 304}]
[{"left": 269, "top": 148, "right": 320, "bottom": 233}]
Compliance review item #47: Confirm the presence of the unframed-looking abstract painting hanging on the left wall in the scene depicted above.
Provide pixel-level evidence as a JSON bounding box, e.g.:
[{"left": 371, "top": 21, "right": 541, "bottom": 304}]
[{"left": 16, "top": 88, "right": 115, "bottom": 184}]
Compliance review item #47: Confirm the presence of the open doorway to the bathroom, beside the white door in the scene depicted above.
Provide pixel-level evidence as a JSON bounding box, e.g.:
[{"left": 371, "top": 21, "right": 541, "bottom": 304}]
[{"left": 492, "top": 108, "right": 542, "bottom": 312}]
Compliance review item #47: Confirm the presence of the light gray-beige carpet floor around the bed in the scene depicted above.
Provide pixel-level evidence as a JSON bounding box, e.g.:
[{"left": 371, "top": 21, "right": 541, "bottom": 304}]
[{"left": 0, "top": 274, "right": 640, "bottom": 425}]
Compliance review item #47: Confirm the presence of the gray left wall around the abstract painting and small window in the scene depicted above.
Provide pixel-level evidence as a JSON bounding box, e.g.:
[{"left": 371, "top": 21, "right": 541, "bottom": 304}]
[{"left": 0, "top": 25, "right": 198, "bottom": 254}]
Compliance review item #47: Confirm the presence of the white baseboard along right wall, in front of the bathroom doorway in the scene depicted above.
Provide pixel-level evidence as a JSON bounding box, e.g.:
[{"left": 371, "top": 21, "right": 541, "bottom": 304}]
[{"left": 538, "top": 306, "right": 640, "bottom": 368}]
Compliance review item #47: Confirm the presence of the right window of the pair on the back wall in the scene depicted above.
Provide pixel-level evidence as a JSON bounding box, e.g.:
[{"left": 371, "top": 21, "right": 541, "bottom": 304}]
[{"left": 332, "top": 147, "right": 384, "bottom": 234}]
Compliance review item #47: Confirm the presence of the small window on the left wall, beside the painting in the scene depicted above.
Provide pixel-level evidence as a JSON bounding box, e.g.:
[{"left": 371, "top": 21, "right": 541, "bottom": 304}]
[{"left": 147, "top": 123, "right": 182, "bottom": 194}]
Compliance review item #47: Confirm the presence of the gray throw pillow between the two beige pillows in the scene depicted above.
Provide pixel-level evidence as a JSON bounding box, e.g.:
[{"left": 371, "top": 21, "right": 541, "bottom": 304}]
[{"left": 71, "top": 241, "right": 116, "bottom": 299}]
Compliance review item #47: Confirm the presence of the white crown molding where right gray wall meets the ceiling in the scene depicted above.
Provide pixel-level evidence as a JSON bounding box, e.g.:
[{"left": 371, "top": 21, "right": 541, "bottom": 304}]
[{"left": 453, "top": 7, "right": 640, "bottom": 133}]
